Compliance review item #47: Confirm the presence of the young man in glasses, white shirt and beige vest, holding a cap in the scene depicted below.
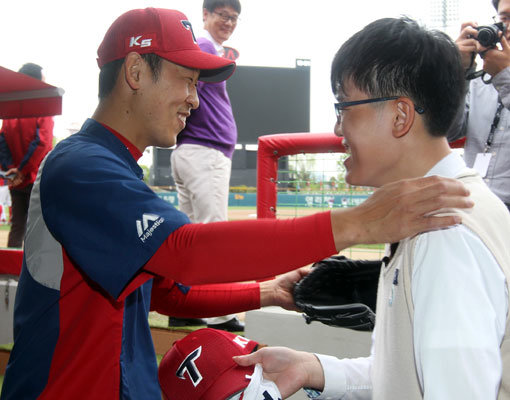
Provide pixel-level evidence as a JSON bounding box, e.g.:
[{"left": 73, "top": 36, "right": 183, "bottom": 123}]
[{"left": 236, "top": 17, "right": 510, "bottom": 400}]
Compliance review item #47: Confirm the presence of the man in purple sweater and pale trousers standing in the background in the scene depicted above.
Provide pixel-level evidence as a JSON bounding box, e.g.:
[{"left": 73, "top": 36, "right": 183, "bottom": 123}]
[{"left": 169, "top": 0, "right": 244, "bottom": 331}]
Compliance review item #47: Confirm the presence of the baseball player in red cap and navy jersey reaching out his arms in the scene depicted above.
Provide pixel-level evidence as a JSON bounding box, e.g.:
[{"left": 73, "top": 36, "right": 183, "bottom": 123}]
[{"left": 1, "top": 8, "right": 473, "bottom": 400}]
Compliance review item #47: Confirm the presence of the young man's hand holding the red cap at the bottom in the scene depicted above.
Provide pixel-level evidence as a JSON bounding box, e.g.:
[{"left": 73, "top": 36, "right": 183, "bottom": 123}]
[{"left": 234, "top": 347, "right": 324, "bottom": 399}]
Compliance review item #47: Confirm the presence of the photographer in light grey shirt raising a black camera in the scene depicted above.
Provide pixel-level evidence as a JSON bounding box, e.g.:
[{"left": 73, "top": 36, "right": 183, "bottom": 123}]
[{"left": 448, "top": 0, "right": 510, "bottom": 209}]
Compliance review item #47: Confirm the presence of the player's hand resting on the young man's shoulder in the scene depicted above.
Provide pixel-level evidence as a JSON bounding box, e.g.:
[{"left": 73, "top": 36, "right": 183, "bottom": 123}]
[{"left": 331, "top": 176, "right": 474, "bottom": 250}]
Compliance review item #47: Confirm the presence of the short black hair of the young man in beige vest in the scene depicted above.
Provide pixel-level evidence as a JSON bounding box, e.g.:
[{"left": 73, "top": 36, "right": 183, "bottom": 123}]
[{"left": 331, "top": 17, "right": 465, "bottom": 136}]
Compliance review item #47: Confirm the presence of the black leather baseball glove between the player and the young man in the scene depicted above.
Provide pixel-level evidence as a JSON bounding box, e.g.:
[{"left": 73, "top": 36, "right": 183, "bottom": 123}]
[{"left": 294, "top": 256, "right": 382, "bottom": 331}]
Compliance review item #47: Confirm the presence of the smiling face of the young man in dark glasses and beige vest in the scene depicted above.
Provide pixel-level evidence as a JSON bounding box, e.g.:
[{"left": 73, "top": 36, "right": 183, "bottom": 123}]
[{"left": 335, "top": 82, "right": 394, "bottom": 187}]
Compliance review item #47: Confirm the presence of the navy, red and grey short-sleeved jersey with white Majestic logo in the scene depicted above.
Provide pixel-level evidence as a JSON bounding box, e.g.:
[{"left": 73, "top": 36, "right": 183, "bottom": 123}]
[{"left": 2, "top": 119, "right": 189, "bottom": 400}]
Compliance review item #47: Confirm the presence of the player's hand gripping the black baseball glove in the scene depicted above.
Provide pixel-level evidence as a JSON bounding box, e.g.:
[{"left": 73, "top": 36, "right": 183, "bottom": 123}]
[{"left": 260, "top": 267, "right": 310, "bottom": 311}]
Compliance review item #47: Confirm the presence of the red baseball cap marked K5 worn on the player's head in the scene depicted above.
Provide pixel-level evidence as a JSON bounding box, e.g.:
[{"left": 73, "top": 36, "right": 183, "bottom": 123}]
[{"left": 97, "top": 8, "right": 235, "bottom": 82}]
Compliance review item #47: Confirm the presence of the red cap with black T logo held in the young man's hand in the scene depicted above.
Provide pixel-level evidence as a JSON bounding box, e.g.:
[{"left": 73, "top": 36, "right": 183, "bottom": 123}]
[{"left": 158, "top": 328, "right": 258, "bottom": 400}]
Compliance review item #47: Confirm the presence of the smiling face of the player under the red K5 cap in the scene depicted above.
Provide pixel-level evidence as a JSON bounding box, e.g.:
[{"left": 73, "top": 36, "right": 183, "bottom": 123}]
[{"left": 140, "top": 60, "right": 199, "bottom": 147}]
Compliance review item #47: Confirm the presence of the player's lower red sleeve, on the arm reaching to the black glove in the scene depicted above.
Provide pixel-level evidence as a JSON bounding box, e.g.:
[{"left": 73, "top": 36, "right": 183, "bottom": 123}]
[{"left": 147, "top": 278, "right": 260, "bottom": 318}]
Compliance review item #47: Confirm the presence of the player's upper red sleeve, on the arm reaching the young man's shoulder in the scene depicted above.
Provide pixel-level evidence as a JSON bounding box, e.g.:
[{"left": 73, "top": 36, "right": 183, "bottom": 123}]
[{"left": 144, "top": 211, "right": 337, "bottom": 285}]
